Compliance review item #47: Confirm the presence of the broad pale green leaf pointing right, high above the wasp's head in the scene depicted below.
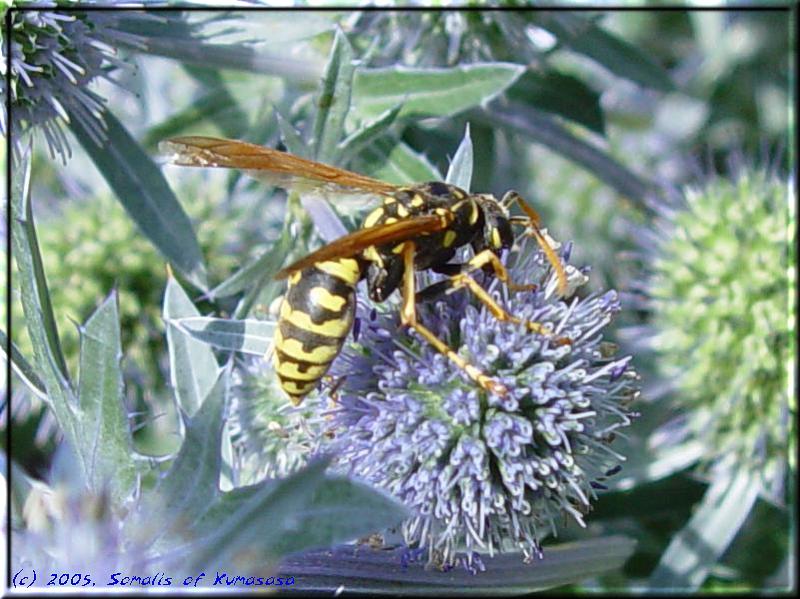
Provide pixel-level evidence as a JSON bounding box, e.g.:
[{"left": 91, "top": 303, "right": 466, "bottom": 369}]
[{"left": 353, "top": 62, "right": 525, "bottom": 120}]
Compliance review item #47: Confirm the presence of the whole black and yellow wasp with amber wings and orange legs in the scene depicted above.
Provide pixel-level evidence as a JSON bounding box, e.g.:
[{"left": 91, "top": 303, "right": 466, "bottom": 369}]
[{"left": 161, "top": 137, "right": 569, "bottom": 405}]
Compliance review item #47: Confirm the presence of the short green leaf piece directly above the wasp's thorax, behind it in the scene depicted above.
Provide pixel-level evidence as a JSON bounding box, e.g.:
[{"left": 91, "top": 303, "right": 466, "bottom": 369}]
[{"left": 354, "top": 136, "right": 442, "bottom": 185}]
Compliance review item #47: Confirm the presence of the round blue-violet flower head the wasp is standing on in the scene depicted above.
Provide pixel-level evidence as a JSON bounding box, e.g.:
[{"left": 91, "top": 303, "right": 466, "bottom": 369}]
[{"left": 320, "top": 242, "right": 637, "bottom": 566}]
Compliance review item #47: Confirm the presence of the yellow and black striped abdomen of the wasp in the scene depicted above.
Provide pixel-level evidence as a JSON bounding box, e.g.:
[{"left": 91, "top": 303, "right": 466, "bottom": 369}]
[{"left": 273, "top": 258, "right": 361, "bottom": 405}]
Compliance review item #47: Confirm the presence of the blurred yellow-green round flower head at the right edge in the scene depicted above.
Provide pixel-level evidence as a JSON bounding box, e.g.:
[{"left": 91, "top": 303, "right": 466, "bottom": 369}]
[{"left": 648, "top": 170, "right": 797, "bottom": 485}]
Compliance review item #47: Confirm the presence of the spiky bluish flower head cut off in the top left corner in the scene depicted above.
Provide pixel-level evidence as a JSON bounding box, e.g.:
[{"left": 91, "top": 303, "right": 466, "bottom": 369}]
[{"left": 0, "top": 0, "right": 224, "bottom": 161}]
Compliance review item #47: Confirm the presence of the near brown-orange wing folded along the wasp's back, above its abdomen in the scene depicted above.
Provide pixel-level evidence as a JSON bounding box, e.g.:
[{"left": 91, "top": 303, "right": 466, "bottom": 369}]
[{"left": 275, "top": 214, "right": 450, "bottom": 279}]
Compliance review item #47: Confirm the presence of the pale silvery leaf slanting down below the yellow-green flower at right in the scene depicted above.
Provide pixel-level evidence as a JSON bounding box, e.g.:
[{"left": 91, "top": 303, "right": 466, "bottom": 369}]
[{"left": 649, "top": 468, "right": 762, "bottom": 592}]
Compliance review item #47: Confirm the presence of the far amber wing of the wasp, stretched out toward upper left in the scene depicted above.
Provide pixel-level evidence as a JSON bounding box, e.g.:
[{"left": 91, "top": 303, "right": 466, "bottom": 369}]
[{"left": 159, "top": 136, "right": 397, "bottom": 195}]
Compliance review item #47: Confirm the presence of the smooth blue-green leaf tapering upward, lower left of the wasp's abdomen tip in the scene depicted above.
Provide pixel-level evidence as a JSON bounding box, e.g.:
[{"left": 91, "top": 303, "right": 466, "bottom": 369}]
[{"left": 141, "top": 368, "right": 230, "bottom": 551}]
